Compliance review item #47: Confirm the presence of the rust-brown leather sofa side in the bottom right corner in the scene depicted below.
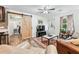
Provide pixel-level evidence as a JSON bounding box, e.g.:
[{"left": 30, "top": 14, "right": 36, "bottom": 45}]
[{"left": 57, "top": 40, "right": 79, "bottom": 54}]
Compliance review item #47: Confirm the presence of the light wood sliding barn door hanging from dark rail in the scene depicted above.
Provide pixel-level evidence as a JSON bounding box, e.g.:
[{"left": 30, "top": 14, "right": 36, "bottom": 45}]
[{"left": 21, "top": 15, "right": 32, "bottom": 39}]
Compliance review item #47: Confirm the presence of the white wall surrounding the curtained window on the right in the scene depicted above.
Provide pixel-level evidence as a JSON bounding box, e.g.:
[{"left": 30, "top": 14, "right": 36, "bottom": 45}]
[{"left": 51, "top": 10, "right": 79, "bottom": 35}]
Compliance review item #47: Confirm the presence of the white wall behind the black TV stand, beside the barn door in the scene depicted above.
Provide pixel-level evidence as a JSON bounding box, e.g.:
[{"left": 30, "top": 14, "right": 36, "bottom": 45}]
[{"left": 32, "top": 15, "right": 48, "bottom": 37}]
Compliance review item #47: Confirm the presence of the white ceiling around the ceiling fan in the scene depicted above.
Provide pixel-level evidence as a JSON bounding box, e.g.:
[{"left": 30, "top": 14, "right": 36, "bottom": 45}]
[{"left": 5, "top": 5, "right": 79, "bottom": 15}]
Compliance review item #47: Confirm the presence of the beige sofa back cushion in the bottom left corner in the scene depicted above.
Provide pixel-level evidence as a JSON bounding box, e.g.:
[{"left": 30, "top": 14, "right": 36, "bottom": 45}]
[{"left": 0, "top": 45, "right": 31, "bottom": 54}]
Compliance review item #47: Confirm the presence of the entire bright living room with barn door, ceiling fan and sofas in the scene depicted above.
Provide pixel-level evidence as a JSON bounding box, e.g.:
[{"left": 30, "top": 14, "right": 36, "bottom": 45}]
[{"left": 0, "top": 5, "right": 79, "bottom": 54}]
